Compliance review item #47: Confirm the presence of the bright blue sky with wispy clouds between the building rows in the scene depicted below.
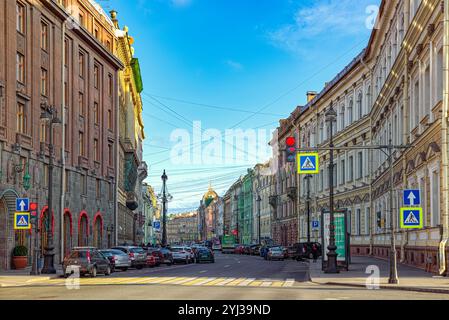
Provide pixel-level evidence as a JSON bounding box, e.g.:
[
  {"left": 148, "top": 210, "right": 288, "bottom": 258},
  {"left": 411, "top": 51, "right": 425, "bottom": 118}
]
[{"left": 103, "top": 0, "right": 380, "bottom": 212}]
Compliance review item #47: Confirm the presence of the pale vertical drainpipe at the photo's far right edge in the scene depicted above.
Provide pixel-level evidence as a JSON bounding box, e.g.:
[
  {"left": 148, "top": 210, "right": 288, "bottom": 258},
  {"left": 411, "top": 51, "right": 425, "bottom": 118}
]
[{"left": 439, "top": 0, "right": 449, "bottom": 275}]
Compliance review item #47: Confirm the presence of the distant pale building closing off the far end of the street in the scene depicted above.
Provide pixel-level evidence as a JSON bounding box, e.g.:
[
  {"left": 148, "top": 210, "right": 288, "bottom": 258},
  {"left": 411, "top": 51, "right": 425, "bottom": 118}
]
[{"left": 167, "top": 211, "right": 199, "bottom": 244}]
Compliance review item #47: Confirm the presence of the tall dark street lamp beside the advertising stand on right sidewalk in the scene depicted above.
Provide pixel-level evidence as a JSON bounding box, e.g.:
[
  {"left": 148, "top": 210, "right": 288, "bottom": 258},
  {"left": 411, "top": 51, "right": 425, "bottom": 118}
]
[{"left": 325, "top": 102, "right": 338, "bottom": 273}]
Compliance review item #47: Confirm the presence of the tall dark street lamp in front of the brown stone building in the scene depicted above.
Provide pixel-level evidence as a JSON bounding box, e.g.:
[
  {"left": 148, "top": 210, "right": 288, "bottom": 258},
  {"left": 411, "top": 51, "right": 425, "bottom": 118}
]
[{"left": 40, "top": 104, "right": 61, "bottom": 274}]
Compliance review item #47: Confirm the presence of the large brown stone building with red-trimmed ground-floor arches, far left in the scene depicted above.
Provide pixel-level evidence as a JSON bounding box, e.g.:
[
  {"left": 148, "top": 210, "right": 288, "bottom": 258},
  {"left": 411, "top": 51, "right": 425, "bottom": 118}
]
[{"left": 0, "top": 0, "right": 123, "bottom": 269}]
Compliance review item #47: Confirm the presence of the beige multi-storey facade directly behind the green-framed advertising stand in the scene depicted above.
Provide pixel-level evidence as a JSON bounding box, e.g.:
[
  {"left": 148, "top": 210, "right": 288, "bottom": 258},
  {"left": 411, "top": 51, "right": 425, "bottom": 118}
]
[{"left": 299, "top": 51, "right": 372, "bottom": 245}]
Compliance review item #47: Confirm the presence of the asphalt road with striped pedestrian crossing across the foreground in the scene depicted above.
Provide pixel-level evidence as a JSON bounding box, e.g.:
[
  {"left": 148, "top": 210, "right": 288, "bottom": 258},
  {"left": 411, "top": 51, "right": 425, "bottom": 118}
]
[{"left": 0, "top": 254, "right": 449, "bottom": 300}]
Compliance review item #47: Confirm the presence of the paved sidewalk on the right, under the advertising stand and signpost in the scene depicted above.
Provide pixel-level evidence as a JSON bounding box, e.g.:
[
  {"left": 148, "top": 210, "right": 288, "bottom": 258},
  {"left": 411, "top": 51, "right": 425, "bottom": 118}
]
[{"left": 309, "top": 257, "right": 449, "bottom": 294}]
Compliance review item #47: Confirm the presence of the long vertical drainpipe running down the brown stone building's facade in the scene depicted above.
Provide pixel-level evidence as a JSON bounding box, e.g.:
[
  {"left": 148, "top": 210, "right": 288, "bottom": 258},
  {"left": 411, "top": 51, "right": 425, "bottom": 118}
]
[{"left": 59, "top": 21, "right": 66, "bottom": 262}]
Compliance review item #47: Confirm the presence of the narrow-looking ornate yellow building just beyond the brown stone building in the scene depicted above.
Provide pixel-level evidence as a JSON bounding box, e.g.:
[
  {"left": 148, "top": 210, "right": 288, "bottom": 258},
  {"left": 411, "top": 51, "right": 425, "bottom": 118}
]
[{"left": 111, "top": 11, "right": 147, "bottom": 244}]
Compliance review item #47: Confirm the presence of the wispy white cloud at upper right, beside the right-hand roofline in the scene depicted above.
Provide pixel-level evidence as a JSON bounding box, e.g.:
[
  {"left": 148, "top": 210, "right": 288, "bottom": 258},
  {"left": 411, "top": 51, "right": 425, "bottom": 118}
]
[{"left": 267, "top": 0, "right": 378, "bottom": 52}]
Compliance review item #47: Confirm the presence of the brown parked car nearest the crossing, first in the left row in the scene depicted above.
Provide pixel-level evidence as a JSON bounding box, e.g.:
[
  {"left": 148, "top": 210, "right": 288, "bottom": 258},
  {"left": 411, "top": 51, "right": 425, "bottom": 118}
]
[{"left": 62, "top": 247, "right": 112, "bottom": 278}]
